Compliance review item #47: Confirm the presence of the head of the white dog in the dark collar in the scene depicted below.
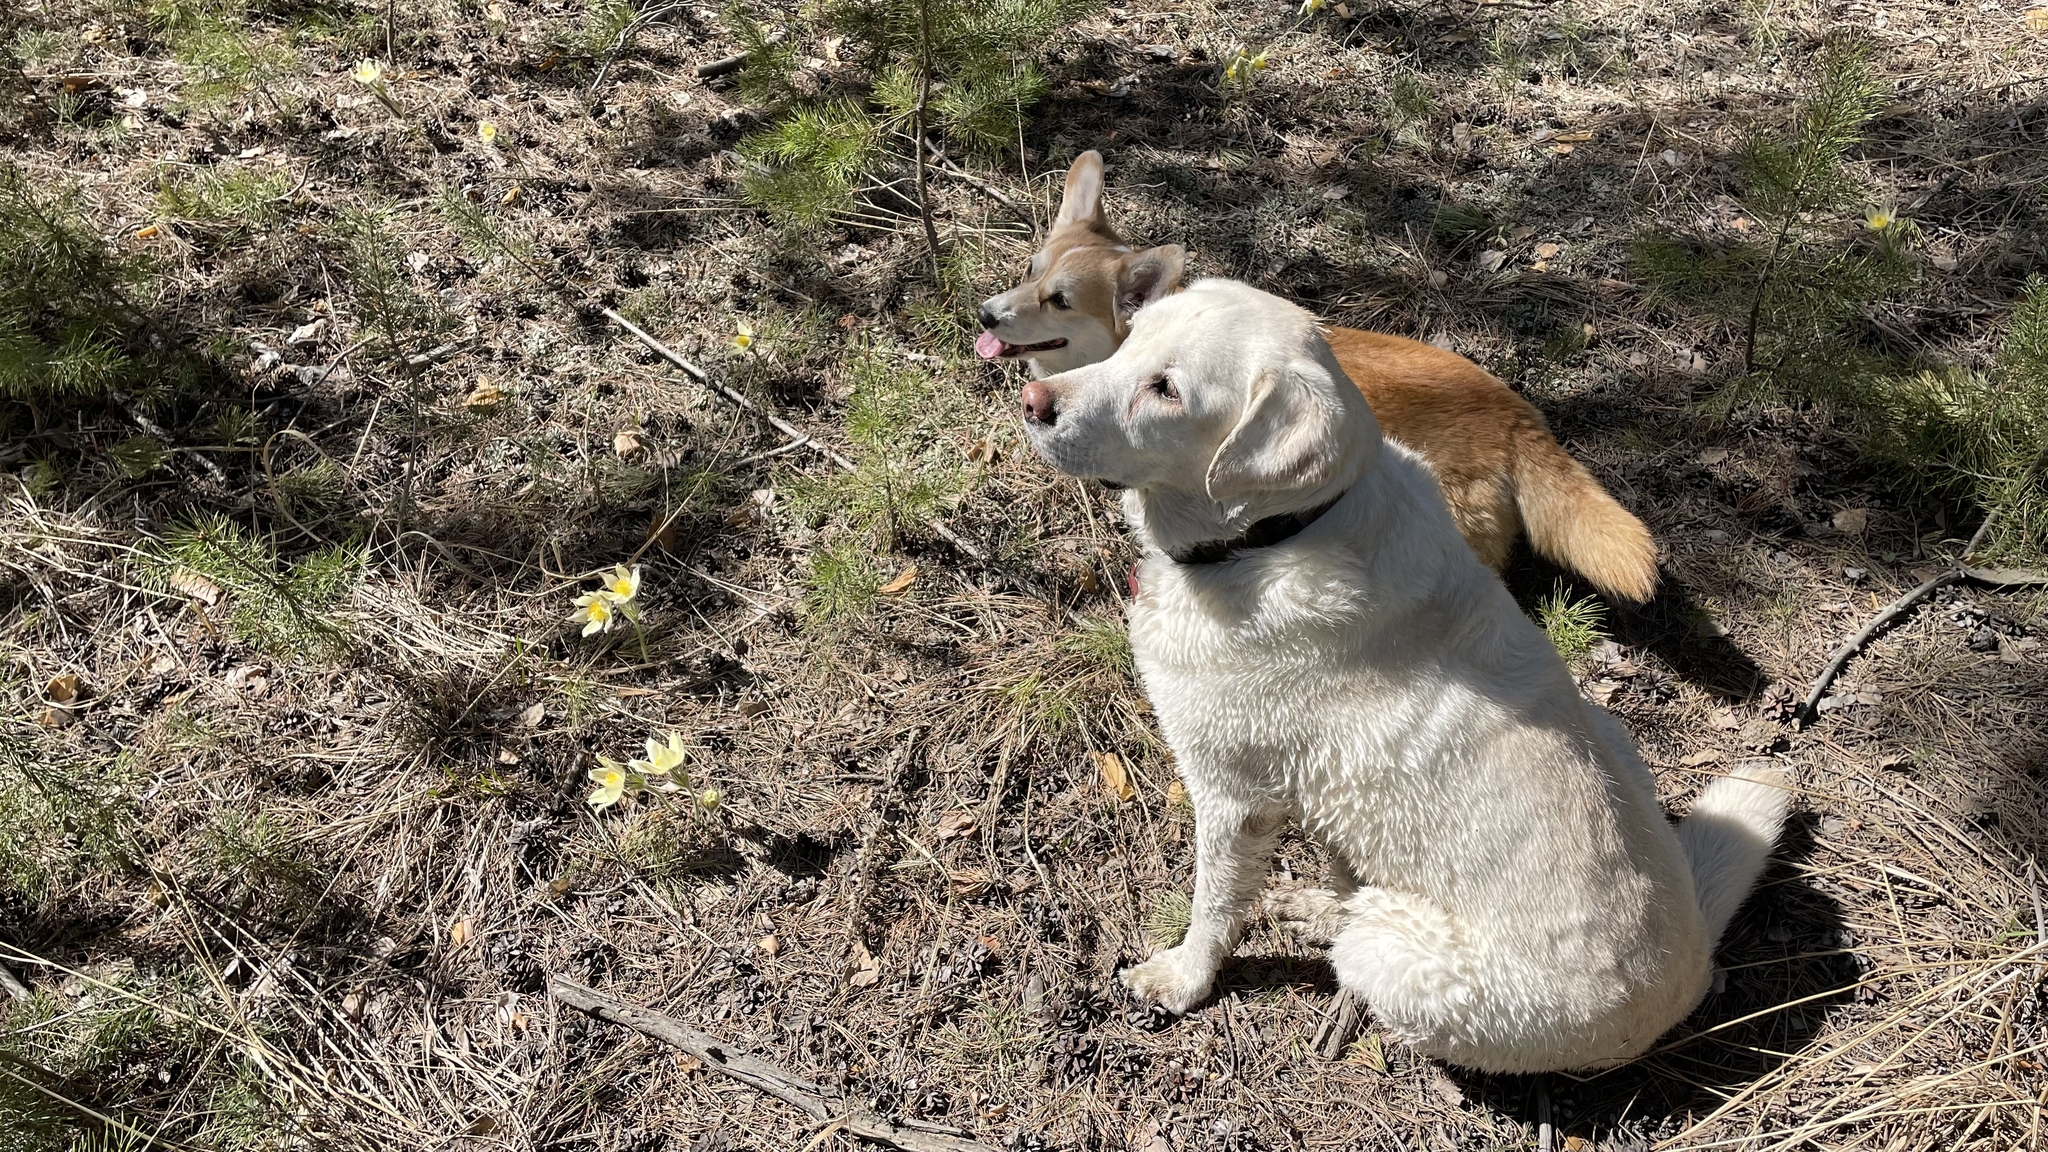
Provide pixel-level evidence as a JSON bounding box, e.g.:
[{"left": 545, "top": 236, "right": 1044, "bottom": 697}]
[{"left": 1022, "top": 272, "right": 1380, "bottom": 549}]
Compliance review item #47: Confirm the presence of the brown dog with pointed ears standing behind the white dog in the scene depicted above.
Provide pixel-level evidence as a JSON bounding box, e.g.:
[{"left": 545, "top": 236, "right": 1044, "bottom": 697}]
[{"left": 975, "top": 152, "right": 1657, "bottom": 603}]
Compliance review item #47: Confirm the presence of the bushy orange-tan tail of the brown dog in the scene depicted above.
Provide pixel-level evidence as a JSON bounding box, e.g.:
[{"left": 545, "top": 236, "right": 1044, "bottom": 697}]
[{"left": 1516, "top": 424, "right": 1657, "bottom": 605}]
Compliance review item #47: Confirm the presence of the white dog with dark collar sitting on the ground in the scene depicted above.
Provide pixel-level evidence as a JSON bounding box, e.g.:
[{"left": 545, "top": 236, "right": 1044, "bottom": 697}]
[{"left": 1022, "top": 281, "right": 1788, "bottom": 1072}]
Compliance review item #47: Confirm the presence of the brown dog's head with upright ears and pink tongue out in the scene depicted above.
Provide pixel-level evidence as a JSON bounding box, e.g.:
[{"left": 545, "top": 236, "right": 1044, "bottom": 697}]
[{"left": 975, "top": 152, "right": 1186, "bottom": 375}]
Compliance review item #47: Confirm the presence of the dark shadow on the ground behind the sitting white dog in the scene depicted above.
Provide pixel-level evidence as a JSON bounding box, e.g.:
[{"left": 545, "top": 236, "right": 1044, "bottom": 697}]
[{"left": 1446, "top": 814, "right": 1866, "bottom": 1148}]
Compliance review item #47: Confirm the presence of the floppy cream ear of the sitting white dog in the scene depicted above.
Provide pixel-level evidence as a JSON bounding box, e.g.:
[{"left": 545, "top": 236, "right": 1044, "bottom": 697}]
[{"left": 1208, "top": 359, "right": 1343, "bottom": 504}]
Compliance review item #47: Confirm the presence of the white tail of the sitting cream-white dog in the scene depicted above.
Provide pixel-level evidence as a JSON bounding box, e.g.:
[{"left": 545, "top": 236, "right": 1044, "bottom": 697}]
[{"left": 1677, "top": 765, "right": 1792, "bottom": 941}]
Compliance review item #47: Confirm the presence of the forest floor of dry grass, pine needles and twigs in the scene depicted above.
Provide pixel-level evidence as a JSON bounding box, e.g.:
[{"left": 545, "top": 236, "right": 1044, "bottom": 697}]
[{"left": 0, "top": 0, "right": 2048, "bottom": 1152}]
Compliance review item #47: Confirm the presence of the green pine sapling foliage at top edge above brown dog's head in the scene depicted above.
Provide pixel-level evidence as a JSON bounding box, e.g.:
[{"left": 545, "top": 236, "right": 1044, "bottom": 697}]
[{"left": 727, "top": 0, "right": 1096, "bottom": 225}]
